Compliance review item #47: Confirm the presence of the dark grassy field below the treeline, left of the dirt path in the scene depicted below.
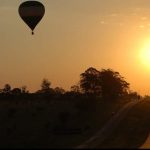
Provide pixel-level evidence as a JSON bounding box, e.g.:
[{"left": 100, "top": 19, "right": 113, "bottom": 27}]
[{"left": 0, "top": 96, "right": 128, "bottom": 148}]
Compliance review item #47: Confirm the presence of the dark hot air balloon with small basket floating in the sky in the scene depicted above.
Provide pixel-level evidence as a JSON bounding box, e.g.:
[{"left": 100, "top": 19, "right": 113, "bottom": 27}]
[{"left": 18, "top": 1, "right": 45, "bottom": 35}]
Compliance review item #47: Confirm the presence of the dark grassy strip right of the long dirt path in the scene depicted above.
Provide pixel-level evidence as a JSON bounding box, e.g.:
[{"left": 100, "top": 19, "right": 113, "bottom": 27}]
[{"left": 97, "top": 100, "right": 150, "bottom": 149}]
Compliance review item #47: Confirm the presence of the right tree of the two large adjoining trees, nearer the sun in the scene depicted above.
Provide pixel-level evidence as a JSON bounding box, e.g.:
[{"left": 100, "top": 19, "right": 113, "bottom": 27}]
[{"left": 100, "top": 69, "right": 129, "bottom": 99}]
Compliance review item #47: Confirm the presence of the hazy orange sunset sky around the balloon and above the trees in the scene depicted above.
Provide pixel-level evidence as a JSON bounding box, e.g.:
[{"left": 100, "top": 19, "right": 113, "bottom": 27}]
[{"left": 0, "top": 0, "right": 150, "bottom": 94}]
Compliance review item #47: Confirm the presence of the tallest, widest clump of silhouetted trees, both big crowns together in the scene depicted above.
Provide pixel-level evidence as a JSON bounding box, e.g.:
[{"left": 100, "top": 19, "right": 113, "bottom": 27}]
[{"left": 80, "top": 67, "right": 129, "bottom": 99}]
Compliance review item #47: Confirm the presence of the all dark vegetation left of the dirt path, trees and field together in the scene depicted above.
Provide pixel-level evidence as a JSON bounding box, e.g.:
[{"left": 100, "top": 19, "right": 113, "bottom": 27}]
[{"left": 0, "top": 67, "right": 140, "bottom": 148}]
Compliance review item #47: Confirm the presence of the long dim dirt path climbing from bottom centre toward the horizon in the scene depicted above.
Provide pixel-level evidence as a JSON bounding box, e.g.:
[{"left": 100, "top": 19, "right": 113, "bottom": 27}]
[{"left": 76, "top": 100, "right": 139, "bottom": 148}]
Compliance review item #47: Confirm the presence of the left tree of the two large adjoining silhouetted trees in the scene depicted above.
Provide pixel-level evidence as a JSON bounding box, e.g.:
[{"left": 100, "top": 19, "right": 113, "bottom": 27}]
[{"left": 80, "top": 67, "right": 101, "bottom": 95}]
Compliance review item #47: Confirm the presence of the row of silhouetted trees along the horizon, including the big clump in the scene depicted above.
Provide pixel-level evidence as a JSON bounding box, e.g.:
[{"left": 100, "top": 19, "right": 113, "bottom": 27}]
[{"left": 0, "top": 67, "right": 139, "bottom": 100}]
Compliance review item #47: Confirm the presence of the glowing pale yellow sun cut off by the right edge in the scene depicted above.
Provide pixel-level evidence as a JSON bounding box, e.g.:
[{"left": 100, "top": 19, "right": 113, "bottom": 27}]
[{"left": 139, "top": 41, "right": 150, "bottom": 69}]
